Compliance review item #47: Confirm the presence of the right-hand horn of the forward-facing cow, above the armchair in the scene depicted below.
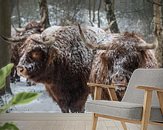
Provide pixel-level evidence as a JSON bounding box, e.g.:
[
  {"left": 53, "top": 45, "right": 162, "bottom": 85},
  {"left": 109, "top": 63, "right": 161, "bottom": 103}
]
[{"left": 137, "top": 37, "right": 158, "bottom": 50}]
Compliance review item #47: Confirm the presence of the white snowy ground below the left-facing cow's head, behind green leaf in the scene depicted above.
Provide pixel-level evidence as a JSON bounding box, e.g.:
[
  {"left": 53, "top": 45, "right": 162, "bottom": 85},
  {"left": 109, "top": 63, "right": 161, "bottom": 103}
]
[{"left": 4, "top": 78, "right": 91, "bottom": 113}]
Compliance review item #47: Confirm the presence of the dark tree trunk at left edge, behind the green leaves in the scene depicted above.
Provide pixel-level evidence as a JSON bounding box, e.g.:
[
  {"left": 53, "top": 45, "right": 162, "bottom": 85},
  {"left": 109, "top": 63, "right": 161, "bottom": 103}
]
[{"left": 0, "top": 0, "right": 11, "bottom": 95}]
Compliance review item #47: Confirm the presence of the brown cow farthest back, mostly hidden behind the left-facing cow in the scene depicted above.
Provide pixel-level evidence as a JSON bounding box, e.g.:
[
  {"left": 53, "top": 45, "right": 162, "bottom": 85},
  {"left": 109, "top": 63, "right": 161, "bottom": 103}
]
[{"left": 8, "top": 21, "right": 43, "bottom": 82}]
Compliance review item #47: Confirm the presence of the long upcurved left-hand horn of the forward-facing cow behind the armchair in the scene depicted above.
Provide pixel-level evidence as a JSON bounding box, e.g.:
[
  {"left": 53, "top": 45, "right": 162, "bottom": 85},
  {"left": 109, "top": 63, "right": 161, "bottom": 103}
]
[{"left": 78, "top": 24, "right": 108, "bottom": 50}]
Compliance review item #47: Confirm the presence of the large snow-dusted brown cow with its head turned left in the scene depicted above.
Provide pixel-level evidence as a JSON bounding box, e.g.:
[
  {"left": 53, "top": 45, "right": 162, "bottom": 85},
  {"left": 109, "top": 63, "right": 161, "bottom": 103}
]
[{"left": 14, "top": 26, "right": 106, "bottom": 112}]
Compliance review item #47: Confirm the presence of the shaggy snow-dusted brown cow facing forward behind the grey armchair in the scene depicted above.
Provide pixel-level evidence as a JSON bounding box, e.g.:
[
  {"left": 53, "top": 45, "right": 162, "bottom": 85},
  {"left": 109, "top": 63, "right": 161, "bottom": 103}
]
[{"left": 81, "top": 27, "right": 157, "bottom": 100}]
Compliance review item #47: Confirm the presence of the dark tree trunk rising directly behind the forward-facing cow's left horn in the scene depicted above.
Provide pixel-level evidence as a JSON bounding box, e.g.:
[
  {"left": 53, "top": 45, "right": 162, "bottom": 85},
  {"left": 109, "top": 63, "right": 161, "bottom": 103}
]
[{"left": 105, "top": 0, "right": 120, "bottom": 33}]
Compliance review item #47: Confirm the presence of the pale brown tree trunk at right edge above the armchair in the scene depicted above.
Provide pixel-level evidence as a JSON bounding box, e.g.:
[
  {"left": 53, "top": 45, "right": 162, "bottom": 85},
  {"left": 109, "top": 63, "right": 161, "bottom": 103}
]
[{"left": 153, "top": 0, "right": 163, "bottom": 68}]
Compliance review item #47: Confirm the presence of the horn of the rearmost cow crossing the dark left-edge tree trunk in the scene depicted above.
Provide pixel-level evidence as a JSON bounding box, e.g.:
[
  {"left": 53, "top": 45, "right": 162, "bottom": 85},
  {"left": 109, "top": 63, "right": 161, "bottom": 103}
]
[{"left": 0, "top": 35, "right": 26, "bottom": 43}]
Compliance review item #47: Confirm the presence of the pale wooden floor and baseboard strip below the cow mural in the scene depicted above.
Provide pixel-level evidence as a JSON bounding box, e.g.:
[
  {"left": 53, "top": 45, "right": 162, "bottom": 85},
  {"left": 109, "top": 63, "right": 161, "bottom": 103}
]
[{"left": 0, "top": 113, "right": 140, "bottom": 130}]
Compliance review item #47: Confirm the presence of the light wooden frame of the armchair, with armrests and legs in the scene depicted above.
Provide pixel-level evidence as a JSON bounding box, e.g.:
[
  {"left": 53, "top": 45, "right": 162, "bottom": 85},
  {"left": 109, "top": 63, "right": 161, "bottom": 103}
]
[{"left": 87, "top": 83, "right": 163, "bottom": 130}]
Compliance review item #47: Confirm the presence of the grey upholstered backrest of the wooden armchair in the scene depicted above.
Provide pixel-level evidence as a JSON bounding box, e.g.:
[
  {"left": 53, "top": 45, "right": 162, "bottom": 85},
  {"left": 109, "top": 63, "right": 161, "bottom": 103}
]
[{"left": 122, "top": 68, "right": 163, "bottom": 106}]
